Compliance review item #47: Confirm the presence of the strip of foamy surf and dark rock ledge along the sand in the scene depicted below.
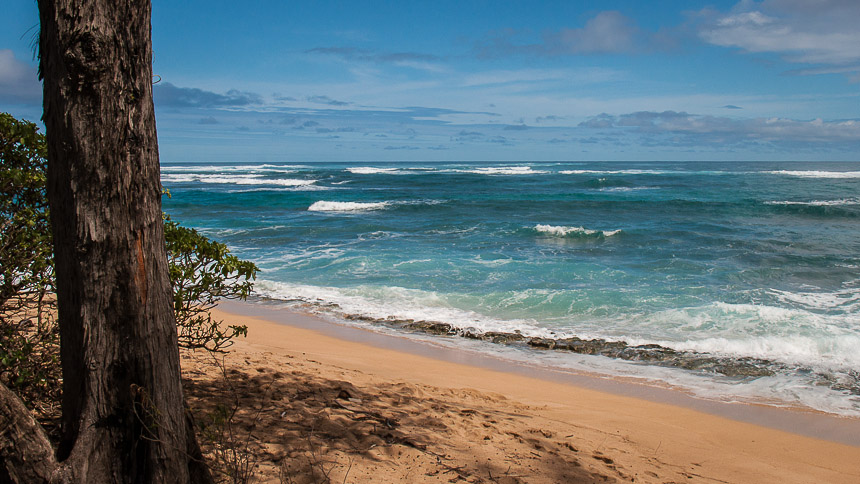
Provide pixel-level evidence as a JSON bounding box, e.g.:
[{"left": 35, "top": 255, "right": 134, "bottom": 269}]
[{"left": 250, "top": 280, "right": 860, "bottom": 419}]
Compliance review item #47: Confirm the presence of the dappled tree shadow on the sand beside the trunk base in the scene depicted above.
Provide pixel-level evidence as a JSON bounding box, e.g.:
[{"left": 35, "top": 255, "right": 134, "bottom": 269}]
[{"left": 185, "top": 352, "right": 630, "bottom": 484}]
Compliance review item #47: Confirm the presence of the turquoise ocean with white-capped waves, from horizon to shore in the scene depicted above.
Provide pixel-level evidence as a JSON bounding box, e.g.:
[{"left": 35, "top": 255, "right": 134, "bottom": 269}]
[{"left": 162, "top": 163, "right": 860, "bottom": 415}]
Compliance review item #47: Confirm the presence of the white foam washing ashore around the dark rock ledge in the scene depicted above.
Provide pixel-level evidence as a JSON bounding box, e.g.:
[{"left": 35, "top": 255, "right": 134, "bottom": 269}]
[{"left": 250, "top": 280, "right": 860, "bottom": 415}]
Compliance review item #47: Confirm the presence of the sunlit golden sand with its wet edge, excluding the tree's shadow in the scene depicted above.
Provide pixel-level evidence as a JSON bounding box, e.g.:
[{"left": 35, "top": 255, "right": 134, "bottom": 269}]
[{"left": 195, "top": 302, "right": 860, "bottom": 484}]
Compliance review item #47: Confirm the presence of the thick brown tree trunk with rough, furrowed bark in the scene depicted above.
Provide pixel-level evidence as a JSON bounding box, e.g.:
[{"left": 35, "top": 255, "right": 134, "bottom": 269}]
[{"left": 38, "top": 0, "right": 211, "bottom": 483}]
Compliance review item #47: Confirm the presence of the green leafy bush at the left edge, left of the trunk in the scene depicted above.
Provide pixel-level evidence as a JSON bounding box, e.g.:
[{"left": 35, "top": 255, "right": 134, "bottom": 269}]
[{"left": 0, "top": 113, "right": 60, "bottom": 415}]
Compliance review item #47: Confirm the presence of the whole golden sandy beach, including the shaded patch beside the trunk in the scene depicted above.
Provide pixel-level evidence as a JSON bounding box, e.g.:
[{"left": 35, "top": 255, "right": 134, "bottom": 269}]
[{"left": 175, "top": 303, "right": 860, "bottom": 483}]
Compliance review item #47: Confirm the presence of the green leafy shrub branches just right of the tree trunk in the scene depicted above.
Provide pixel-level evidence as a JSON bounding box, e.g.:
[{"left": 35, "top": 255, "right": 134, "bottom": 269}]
[{"left": 164, "top": 218, "right": 258, "bottom": 351}]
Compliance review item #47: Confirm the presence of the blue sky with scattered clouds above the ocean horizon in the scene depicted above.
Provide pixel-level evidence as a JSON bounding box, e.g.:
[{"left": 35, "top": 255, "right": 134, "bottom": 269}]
[{"left": 0, "top": 0, "right": 860, "bottom": 162}]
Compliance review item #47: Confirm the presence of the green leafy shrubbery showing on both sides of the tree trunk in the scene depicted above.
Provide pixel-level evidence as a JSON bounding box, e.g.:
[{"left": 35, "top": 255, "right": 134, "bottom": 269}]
[{"left": 0, "top": 113, "right": 257, "bottom": 412}]
